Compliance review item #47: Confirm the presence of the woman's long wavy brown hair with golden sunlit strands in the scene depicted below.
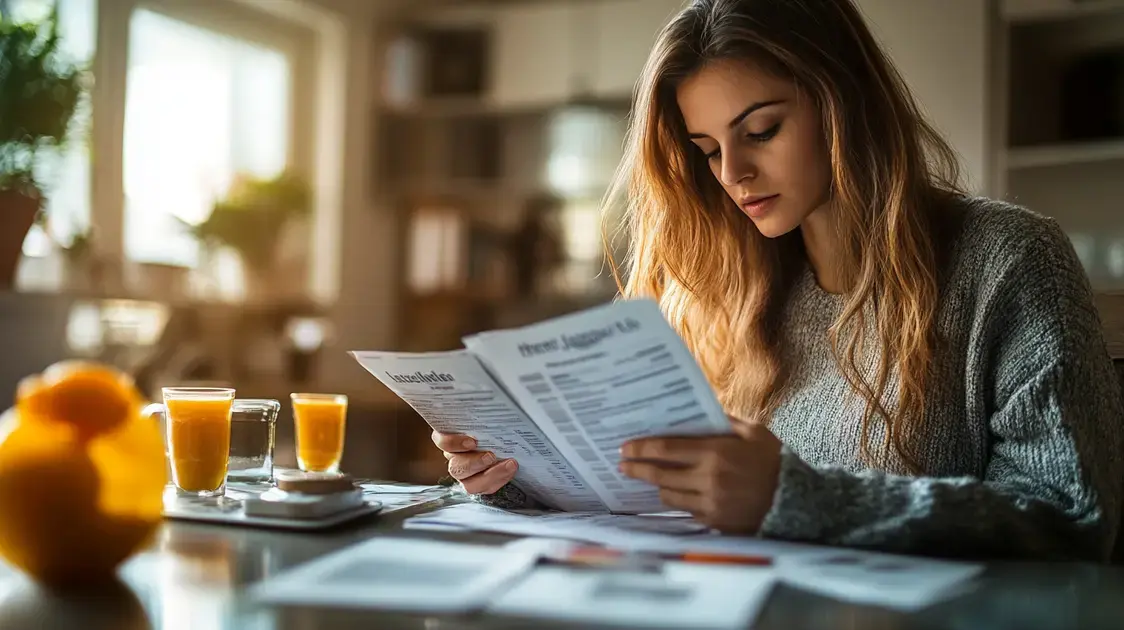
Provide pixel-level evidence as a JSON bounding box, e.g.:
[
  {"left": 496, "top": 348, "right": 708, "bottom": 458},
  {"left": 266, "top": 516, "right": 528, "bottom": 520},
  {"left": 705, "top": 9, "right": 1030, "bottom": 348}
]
[{"left": 607, "top": 0, "right": 960, "bottom": 470}]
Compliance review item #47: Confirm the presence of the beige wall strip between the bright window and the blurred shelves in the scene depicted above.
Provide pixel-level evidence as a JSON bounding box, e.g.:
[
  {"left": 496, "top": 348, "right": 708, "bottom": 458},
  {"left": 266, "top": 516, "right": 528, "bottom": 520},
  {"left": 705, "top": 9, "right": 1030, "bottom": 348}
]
[{"left": 242, "top": 0, "right": 402, "bottom": 393}]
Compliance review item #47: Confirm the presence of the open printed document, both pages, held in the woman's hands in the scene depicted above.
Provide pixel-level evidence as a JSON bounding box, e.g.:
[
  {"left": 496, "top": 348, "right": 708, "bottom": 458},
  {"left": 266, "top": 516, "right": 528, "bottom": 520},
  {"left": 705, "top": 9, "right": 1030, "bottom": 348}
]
[{"left": 352, "top": 299, "right": 731, "bottom": 514}]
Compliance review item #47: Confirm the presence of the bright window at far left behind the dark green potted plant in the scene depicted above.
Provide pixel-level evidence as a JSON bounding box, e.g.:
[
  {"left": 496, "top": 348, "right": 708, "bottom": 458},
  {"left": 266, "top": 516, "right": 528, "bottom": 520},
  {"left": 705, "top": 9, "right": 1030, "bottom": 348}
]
[{"left": 8, "top": 0, "right": 98, "bottom": 257}]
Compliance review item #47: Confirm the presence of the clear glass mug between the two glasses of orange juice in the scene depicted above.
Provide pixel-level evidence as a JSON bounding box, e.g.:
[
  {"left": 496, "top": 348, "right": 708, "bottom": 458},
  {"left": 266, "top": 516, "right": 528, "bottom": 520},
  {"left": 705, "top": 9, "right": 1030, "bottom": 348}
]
[{"left": 226, "top": 398, "right": 281, "bottom": 484}]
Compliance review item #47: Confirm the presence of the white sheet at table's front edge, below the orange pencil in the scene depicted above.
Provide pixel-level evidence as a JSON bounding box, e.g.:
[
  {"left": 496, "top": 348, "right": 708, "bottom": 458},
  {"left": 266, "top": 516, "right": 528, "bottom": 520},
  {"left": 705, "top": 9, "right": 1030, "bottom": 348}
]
[{"left": 487, "top": 563, "right": 773, "bottom": 628}]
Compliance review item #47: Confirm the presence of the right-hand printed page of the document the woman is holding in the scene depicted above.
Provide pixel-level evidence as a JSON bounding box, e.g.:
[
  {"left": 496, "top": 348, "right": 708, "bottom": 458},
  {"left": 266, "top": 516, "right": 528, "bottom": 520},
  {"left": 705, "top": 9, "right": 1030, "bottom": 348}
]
[{"left": 463, "top": 299, "right": 732, "bottom": 513}]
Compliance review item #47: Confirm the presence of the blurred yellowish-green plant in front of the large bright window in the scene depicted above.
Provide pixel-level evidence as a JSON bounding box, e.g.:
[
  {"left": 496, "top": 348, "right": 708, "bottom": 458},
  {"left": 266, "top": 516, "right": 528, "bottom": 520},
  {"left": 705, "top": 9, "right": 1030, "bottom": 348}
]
[{"left": 189, "top": 172, "right": 311, "bottom": 294}]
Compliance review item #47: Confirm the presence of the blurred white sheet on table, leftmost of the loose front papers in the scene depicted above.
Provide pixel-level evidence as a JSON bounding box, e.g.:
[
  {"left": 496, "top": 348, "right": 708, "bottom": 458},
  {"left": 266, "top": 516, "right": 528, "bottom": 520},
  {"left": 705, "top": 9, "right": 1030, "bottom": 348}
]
[{"left": 251, "top": 538, "right": 535, "bottom": 612}]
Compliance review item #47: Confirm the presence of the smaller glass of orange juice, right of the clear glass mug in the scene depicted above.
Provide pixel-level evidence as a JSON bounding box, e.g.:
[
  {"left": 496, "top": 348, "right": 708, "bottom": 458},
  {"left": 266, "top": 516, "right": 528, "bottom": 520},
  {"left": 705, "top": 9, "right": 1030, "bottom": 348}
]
[{"left": 289, "top": 394, "right": 347, "bottom": 473}]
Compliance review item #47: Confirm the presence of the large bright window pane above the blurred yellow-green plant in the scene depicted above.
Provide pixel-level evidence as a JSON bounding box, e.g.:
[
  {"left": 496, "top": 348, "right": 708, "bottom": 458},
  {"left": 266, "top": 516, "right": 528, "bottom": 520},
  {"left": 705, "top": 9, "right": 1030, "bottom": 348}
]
[{"left": 124, "top": 10, "right": 291, "bottom": 267}]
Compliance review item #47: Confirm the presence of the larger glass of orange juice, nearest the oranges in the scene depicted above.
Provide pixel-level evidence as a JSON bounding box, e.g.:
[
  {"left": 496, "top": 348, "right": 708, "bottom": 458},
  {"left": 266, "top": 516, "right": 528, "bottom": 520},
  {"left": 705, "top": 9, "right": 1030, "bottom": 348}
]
[{"left": 163, "top": 387, "right": 234, "bottom": 497}]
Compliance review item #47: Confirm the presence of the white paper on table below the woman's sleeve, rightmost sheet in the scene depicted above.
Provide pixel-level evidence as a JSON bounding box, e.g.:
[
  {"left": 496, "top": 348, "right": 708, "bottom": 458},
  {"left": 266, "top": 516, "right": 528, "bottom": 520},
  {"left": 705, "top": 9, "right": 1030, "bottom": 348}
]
[{"left": 778, "top": 549, "right": 984, "bottom": 611}]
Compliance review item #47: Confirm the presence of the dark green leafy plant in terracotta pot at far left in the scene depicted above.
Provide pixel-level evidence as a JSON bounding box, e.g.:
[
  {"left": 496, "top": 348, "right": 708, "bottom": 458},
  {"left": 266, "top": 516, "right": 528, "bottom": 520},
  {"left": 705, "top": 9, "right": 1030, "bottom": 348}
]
[{"left": 0, "top": 9, "right": 83, "bottom": 290}]
